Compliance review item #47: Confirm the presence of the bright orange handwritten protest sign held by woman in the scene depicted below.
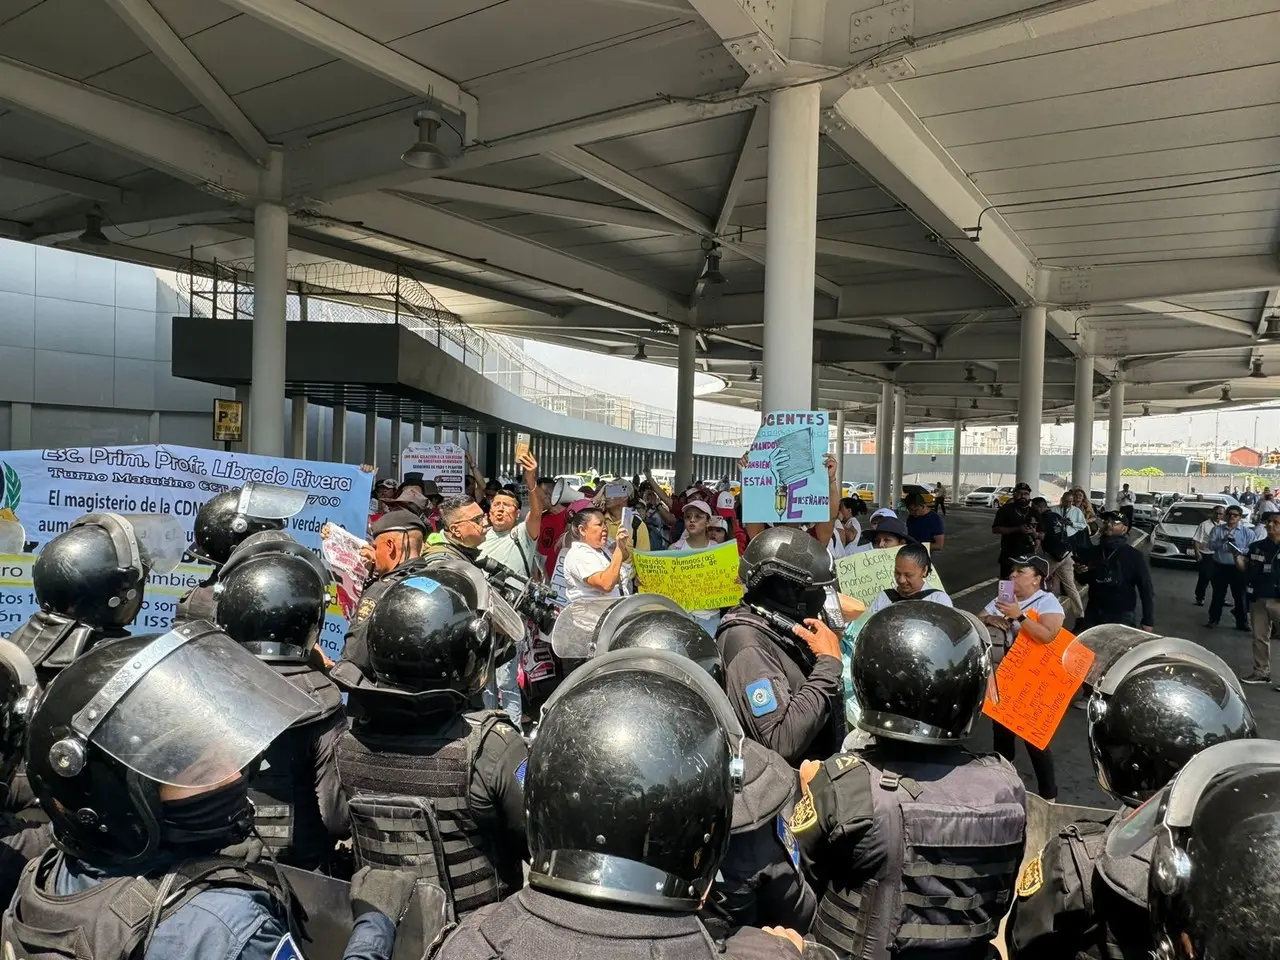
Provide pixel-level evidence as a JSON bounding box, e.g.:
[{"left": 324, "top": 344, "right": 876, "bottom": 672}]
[{"left": 982, "top": 611, "right": 1093, "bottom": 750}]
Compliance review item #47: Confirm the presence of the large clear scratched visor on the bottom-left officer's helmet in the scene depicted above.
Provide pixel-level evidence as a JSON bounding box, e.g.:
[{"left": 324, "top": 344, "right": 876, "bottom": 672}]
[{"left": 72, "top": 621, "right": 319, "bottom": 787}]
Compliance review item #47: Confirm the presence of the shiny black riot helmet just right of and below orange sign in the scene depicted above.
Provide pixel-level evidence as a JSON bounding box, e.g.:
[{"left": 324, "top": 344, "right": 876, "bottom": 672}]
[{"left": 1088, "top": 634, "right": 1258, "bottom": 806}]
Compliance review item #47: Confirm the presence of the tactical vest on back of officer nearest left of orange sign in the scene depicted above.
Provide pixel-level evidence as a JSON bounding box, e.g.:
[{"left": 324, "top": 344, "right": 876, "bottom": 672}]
[{"left": 813, "top": 756, "right": 1027, "bottom": 960}]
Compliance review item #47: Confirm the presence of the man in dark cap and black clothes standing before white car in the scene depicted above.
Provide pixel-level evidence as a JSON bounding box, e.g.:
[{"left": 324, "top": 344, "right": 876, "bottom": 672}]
[{"left": 1075, "top": 509, "right": 1156, "bottom": 634}]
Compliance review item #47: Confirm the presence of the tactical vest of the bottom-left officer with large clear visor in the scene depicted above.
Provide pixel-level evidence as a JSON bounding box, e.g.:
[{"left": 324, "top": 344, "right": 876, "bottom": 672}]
[{"left": 0, "top": 847, "right": 288, "bottom": 960}]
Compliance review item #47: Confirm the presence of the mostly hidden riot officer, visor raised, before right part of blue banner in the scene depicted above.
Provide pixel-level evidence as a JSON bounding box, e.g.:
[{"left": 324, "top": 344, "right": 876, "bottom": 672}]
[{"left": 174, "top": 483, "right": 307, "bottom": 622}]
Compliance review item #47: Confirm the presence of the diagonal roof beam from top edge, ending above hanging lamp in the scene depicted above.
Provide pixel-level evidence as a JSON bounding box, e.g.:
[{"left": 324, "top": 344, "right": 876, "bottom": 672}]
[{"left": 215, "top": 0, "right": 479, "bottom": 124}]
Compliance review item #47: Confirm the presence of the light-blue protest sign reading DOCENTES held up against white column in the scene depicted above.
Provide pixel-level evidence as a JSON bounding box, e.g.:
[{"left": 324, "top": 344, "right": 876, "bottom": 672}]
[{"left": 742, "top": 410, "right": 831, "bottom": 524}]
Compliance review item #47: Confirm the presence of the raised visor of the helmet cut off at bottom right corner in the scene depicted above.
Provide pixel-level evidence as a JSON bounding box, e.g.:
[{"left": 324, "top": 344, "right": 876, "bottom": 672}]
[{"left": 1106, "top": 740, "right": 1280, "bottom": 858}]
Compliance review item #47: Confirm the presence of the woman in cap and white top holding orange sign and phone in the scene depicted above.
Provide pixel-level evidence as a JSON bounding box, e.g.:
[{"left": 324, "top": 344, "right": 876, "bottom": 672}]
[{"left": 980, "top": 557, "right": 1066, "bottom": 800}]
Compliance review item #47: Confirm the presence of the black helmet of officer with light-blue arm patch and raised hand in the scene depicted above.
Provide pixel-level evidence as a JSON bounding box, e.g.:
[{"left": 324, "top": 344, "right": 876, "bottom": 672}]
[{"left": 739, "top": 526, "right": 836, "bottom": 621}]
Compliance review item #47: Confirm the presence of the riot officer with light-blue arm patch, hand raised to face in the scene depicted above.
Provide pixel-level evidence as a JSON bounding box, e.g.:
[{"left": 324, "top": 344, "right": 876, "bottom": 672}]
[{"left": 716, "top": 526, "right": 845, "bottom": 764}]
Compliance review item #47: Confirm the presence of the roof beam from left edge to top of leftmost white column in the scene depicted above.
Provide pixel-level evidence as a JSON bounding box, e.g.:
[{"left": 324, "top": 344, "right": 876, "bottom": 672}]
[{"left": 0, "top": 58, "right": 262, "bottom": 197}]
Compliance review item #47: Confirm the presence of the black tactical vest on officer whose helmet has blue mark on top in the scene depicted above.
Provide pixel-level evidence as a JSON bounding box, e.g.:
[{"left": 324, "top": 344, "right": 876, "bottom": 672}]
[{"left": 337, "top": 710, "right": 521, "bottom": 916}]
